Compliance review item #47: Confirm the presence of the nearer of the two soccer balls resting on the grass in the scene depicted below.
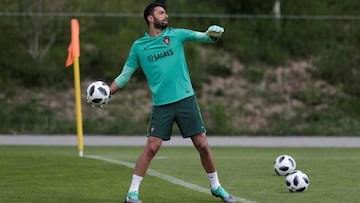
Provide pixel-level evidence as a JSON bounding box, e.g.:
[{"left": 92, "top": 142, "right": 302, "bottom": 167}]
[{"left": 285, "top": 170, "right": 309, "bottom": 192}]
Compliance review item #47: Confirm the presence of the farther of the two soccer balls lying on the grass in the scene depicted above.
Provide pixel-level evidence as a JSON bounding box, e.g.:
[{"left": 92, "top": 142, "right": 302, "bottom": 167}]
[{"left": 274, "top": 154, "right": 296, "bottom": 176}]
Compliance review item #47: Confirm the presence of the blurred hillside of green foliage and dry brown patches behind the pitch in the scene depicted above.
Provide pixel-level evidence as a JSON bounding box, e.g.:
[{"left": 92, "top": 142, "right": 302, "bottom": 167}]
[{"left": 0, "top": 0, "right": 360, "bottom": 135}]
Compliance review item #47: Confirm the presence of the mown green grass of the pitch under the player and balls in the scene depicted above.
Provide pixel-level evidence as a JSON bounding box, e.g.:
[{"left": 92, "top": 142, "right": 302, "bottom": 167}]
[{"left": 0, "top": 146, "right": 360, "bottom": 203}]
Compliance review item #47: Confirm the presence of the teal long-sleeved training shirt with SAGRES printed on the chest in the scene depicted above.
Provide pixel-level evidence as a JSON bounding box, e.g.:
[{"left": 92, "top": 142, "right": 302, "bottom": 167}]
[{"left": 115, "top": 28, "right": 214, "bottom": 106}]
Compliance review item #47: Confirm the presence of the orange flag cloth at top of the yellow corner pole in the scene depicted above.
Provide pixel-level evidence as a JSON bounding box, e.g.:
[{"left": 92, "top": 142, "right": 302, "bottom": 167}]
[{"left": 65, "top": 19, "right": 80, "bottom": 67}]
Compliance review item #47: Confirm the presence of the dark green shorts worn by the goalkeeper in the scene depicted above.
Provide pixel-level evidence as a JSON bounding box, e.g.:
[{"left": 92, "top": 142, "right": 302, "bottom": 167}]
[{"left": 147, "top": 96, "right": 206, "bottom": 140}]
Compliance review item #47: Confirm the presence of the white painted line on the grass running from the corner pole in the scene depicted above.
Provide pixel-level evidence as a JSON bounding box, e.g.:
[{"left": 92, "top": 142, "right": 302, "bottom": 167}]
[{"left": 84, "top": 155, "right": 257, "bottom": 203}]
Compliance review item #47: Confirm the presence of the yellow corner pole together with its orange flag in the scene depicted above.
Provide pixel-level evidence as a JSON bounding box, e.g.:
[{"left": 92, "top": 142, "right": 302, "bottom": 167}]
[{"left": 65, "top": 19, "right": 84, "bottom": 157}]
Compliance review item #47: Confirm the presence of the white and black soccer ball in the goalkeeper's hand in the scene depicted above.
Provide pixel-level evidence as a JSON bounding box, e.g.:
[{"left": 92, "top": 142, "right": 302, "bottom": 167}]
[{"left": 86, "top": 81, "right": 110, "bottom": 107}]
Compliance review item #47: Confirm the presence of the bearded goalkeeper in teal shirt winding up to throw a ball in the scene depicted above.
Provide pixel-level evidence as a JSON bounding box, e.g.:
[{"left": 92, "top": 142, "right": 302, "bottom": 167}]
[{"left": 110, "top": 3, "right": 236, "bottom": 203}]
